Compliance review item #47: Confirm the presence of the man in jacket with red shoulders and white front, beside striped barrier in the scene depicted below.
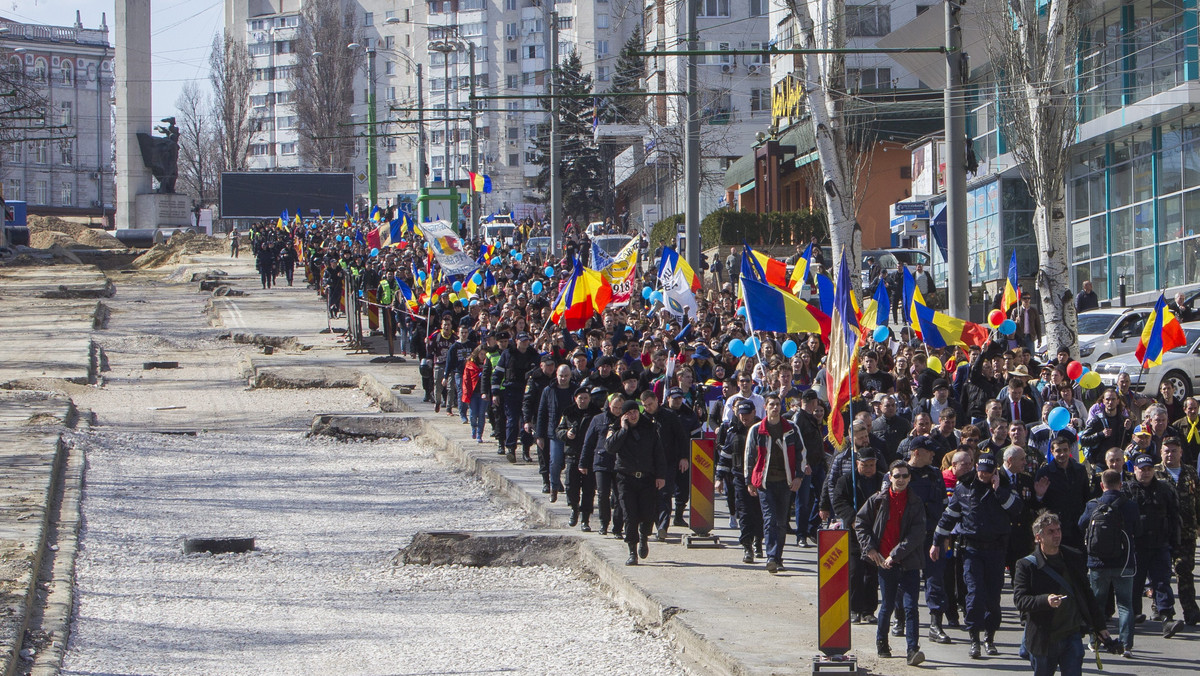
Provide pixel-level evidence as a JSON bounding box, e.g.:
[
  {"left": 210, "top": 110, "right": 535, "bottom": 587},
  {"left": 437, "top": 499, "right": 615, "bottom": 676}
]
[{"left": 745, "top": 393, "right": 810, "bottom": 574}]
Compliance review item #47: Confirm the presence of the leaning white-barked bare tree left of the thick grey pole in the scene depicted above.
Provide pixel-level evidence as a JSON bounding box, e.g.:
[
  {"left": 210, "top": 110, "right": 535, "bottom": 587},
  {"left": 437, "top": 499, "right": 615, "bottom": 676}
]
[{"left": 786, "top": 0, "right": 871, "bottom": 279}]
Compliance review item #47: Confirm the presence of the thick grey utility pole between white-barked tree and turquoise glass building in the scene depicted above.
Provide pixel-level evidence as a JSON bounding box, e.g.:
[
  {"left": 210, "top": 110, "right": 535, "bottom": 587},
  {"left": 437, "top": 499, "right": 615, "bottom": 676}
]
[{"left": 943, "top": 0, "right": 971, "bottom": 319}]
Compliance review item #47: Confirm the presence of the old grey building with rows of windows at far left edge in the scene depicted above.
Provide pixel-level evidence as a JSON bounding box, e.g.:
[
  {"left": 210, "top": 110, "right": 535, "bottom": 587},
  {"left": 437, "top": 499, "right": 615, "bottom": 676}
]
[{"left": 0, "top": 12, "right": 116, "bottom": 216}]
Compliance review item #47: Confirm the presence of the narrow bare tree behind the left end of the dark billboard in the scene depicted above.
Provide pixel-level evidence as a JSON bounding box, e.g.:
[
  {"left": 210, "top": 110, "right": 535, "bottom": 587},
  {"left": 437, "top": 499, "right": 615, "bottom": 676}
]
[{"left": 209, "top": 34, "right": 253, "bottom": 172}]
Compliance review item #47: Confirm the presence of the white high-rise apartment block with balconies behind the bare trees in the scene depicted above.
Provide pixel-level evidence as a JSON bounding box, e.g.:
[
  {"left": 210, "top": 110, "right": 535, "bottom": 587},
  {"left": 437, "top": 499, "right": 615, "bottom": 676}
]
[{"left": 226, "top": 0, "right": 641, "bottom": 216}]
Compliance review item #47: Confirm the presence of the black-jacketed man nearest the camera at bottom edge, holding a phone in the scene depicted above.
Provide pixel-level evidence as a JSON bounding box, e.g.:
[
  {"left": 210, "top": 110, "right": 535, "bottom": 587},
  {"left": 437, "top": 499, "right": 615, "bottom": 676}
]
[{"left": 1013, "top": 512, "right": 1112, "bottom": 676}]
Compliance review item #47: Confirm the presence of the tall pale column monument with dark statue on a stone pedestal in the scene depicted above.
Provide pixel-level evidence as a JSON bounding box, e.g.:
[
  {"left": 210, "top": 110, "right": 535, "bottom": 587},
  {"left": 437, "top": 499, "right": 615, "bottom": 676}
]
[{"left": 114, "top": 0, "right": 192, "bottom": 231}]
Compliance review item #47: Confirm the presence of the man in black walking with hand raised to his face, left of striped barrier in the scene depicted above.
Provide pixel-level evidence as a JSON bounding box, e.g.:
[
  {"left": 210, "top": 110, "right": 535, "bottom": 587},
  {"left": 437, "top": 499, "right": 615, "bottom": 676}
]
[{"left": 605, "top": 401, "right": 667, "bottom": 566}]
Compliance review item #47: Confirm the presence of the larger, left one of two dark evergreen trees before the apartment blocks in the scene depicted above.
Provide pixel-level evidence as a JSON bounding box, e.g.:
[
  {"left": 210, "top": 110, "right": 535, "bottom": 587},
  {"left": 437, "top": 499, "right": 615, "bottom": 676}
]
[{"left": 533, "top": 52, "right": 606, "bottom": 223}]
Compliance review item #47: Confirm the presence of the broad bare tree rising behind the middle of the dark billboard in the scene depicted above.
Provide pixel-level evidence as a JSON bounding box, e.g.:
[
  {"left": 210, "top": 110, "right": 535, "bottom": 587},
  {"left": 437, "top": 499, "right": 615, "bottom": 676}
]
[{"left": 292, "top": 0, "right": 366, "bottom": 171}]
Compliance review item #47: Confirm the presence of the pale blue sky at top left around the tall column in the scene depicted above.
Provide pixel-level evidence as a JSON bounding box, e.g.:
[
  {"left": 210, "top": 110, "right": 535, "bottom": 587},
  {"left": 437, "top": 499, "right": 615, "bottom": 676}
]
[{"left": 0, "top": 0, "right": 224, "bottom": 121}]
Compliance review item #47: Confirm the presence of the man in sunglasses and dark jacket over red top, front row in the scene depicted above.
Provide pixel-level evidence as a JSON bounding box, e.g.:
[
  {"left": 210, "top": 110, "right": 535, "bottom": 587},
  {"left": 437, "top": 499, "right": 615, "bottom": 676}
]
[{"left": 854, "top": 460, "right": 925, "bottom": 666}]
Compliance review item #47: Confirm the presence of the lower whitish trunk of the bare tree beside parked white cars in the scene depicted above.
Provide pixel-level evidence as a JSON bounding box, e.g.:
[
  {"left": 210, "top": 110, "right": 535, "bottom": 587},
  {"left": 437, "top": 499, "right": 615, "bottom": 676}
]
[{"left": 1033, "top": 201, "right": 1079, "bottom": 359}]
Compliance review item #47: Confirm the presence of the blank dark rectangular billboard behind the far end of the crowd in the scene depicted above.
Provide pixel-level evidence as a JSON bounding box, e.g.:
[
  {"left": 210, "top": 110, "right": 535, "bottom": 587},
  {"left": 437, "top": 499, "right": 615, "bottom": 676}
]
[{"left": 221, "top": 172, "right": 354, "bottom": 219}]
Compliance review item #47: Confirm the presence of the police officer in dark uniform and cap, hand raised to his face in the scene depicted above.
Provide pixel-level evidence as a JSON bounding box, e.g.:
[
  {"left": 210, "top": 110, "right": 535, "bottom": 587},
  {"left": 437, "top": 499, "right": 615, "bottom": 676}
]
[{"left": 929, "top": 454, "right": 1024, "bottom": 659}]
